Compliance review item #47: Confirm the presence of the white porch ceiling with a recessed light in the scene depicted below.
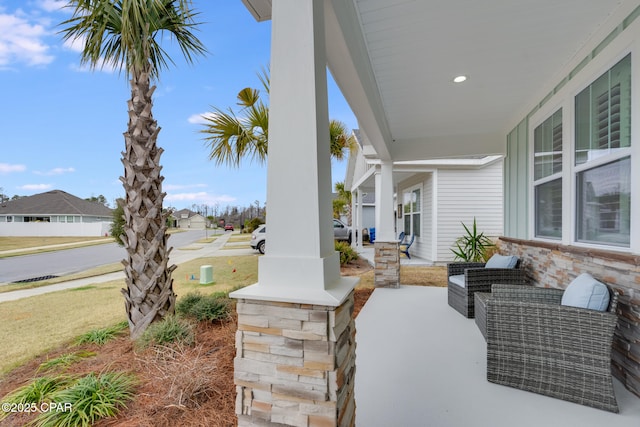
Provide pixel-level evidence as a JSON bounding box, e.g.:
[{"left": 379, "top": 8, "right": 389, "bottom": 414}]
[{"left": 243, "top": 0, "right": 638, "bottom": 160}]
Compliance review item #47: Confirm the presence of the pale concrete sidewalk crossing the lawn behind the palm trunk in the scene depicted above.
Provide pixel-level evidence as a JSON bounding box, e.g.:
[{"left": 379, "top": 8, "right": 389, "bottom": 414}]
[{"left": 0, "top": 233, "right": 258, "bottom": 302}]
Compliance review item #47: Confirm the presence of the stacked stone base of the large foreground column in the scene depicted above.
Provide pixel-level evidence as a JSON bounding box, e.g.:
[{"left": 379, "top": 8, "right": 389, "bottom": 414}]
[{"left": 234, "top": 292, "right": 356, "bottom": 427}]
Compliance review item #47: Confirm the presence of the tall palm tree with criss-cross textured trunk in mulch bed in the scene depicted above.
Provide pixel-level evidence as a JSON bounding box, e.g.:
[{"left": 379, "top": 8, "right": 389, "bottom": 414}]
[{"left": 61, "top": 0, "right": 206, "bottom": 339}]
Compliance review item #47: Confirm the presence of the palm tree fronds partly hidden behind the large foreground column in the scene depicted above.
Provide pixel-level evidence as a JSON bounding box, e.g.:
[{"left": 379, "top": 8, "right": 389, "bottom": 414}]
[{"left": 201, "top": 70, "right": 355, "bottom": 167}]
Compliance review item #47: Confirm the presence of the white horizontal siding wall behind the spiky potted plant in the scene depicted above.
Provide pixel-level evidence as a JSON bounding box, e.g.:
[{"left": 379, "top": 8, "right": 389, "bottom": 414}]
[{"left": 435, "top": 162, "right": 503, "bottom": 262}]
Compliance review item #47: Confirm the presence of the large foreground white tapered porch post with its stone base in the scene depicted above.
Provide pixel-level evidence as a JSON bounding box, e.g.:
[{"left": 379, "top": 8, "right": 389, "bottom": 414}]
[{"left": 231, "top": 0, "right": 357, "bottom": 427}]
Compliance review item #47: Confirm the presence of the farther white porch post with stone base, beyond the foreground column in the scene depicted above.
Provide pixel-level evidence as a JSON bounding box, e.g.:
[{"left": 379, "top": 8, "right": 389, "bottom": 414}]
[{"left": 374, "top": 160, "right": 400, "bottom": 288}]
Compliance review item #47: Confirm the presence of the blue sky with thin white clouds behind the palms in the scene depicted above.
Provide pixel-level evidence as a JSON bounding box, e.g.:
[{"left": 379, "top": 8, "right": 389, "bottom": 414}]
[{"left": 0, "top": 0, "right": 357, "bottom": 209}]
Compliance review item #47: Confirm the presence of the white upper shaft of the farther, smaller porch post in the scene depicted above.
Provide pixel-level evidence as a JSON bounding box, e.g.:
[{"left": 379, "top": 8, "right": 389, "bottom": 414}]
[{"left": 375, "top": 161, "right": 398, "bottom": 242}]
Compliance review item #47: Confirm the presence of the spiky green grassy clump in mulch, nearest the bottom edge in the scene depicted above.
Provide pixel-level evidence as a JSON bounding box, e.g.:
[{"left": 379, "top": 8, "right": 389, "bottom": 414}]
[{"left": 34, "top": 372, "right": 136, "bottom": 427}]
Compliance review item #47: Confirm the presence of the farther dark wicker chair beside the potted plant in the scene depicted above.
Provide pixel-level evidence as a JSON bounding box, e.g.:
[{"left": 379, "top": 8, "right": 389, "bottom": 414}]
[{"left": 447, "top": 260, "right": 527, "bottom": 318}]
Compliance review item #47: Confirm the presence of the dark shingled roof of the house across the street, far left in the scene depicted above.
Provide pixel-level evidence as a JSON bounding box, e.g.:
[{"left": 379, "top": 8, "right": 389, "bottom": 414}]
[{"left": 0, "top": 190, "right": 112, "bottom": 217}]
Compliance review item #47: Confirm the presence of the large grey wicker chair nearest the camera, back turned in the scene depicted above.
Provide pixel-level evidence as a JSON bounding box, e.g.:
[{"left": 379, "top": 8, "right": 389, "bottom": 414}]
[{"left": 486, "top": 285, "right": 618, "bottom": 412}]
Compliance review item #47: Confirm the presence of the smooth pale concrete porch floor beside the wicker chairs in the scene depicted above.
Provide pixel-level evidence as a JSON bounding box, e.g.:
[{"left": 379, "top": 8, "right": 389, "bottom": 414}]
[{"left": 355, "top": 286, "right": 640, "bottom": 427}]
